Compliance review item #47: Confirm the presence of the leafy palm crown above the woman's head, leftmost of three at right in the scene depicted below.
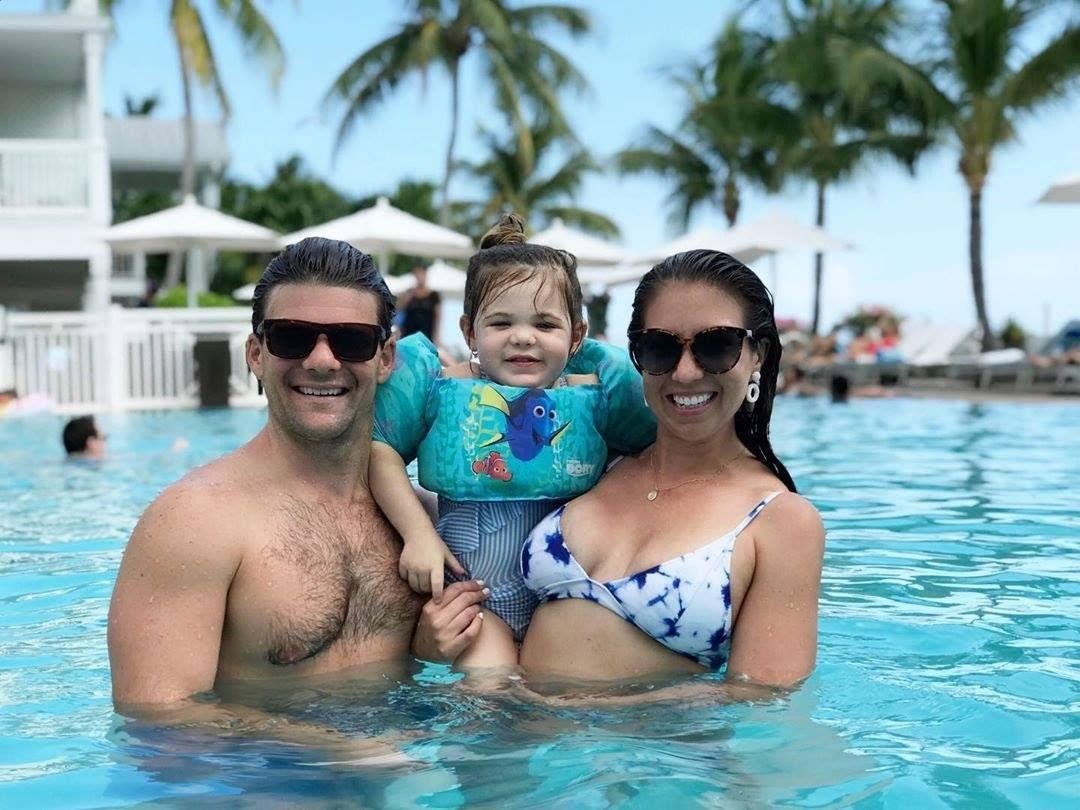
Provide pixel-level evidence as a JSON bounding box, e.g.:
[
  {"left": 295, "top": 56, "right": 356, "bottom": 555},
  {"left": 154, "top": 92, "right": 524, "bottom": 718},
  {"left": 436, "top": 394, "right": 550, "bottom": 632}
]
[{"left": 616, "top": 19, "right": 796, "bottom": 229}]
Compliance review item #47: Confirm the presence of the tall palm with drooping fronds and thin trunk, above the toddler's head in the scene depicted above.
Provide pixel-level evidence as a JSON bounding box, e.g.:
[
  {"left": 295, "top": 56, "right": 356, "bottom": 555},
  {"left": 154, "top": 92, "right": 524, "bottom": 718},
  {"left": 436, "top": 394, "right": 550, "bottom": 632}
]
[{"left": 324, "top": 0, "right": 591, "bottom": 225}]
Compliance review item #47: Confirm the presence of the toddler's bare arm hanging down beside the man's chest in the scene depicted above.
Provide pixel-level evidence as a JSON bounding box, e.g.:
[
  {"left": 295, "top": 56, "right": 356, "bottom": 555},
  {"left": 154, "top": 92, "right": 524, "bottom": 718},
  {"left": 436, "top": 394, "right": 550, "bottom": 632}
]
[{"left": 368, "top": 441, "right": 465, "bottom": 599}]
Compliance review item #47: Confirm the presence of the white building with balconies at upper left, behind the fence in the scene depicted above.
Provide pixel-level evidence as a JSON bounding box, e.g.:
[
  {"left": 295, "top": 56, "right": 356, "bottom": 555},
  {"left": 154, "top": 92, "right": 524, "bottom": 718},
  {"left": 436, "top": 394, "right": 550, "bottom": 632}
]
[{"left": 0, "top": 0, "right": 228, "bottom": 311}]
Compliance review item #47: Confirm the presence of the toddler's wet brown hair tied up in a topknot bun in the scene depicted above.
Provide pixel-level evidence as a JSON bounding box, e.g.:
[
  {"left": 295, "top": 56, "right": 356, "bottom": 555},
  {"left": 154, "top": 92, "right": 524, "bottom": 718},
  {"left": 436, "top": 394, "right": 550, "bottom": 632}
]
[{"left": 464, "top": 214, "right": 582, "bottom": 327}]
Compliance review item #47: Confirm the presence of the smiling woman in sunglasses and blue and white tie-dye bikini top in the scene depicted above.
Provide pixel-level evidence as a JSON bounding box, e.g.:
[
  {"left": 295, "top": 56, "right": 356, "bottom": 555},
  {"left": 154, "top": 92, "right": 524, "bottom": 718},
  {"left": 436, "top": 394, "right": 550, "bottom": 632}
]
[{"left": 416, "top": 251, "right": 824, "bottom": 686}]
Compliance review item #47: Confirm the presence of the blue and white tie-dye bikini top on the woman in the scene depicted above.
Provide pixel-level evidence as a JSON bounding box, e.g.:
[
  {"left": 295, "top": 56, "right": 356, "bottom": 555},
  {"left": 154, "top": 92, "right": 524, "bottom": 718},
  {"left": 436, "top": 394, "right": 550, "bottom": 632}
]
[{"left": 522, "top": 491, "right": 780, "bottom": 670}]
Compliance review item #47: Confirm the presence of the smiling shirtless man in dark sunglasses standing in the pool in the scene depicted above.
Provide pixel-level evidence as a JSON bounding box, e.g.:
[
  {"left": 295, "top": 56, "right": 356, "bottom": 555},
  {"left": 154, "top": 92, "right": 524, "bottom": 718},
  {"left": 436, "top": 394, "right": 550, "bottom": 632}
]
[{"left": 109, "top": 239, "right": 420, "bottom": 727}]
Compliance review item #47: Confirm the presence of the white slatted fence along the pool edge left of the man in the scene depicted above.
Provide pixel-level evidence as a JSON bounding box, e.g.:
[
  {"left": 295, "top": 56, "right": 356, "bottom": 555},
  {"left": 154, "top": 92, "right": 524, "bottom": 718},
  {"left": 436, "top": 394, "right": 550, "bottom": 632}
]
[{"left": 0, "top": 307, "right": 261, "bottom": 411}]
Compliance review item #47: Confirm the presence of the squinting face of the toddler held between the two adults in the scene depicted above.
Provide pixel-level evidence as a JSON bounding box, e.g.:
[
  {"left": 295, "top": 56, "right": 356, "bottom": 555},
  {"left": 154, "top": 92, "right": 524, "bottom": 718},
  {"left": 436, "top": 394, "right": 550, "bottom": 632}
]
[{"left": 461, "top": 276, "right": 584, "bottom": 388}]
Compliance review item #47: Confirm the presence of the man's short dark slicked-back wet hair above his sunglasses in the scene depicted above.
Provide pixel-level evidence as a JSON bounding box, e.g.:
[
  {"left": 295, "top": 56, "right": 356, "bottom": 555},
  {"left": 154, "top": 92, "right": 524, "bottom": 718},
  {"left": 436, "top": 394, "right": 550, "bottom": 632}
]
[{"left": 252, "top": 237, "right": 394, "bottom": 335}]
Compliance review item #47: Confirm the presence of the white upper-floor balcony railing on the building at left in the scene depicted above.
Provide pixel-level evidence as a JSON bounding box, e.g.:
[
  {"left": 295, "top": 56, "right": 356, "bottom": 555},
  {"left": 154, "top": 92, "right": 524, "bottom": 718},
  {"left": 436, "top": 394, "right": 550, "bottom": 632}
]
[{"left": 0, "top": 139, "right": 90, "bottom": 214}]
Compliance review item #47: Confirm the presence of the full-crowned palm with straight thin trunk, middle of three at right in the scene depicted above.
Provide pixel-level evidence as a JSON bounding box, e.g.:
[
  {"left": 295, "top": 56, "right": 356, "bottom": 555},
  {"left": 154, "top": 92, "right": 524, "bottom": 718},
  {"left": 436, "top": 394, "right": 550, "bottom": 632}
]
[{"left": 769, "top": 0, "right": 931, "bottom": 334}]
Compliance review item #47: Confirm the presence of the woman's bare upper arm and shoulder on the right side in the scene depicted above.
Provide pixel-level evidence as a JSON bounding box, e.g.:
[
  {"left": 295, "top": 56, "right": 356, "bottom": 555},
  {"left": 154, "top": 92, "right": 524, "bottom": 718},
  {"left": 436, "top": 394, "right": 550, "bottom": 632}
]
[{"left": 728, "top": 495, "right": 825, "bottom": 687}]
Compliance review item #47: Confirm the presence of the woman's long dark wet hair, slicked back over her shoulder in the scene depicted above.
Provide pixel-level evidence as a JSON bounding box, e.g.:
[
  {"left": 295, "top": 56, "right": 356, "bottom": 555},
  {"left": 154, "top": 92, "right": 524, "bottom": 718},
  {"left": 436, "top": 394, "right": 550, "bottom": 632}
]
[{"left": 626, "top": 251, "right": 797, "bottom": 492}]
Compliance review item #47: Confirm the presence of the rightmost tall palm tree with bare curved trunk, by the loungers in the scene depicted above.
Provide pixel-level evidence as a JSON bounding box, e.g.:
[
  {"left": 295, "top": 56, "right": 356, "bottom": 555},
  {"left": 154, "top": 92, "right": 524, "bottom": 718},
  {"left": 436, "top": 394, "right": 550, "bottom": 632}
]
[{"left": 920, "top": 0, "right": 1080, "bottom": 351}]
